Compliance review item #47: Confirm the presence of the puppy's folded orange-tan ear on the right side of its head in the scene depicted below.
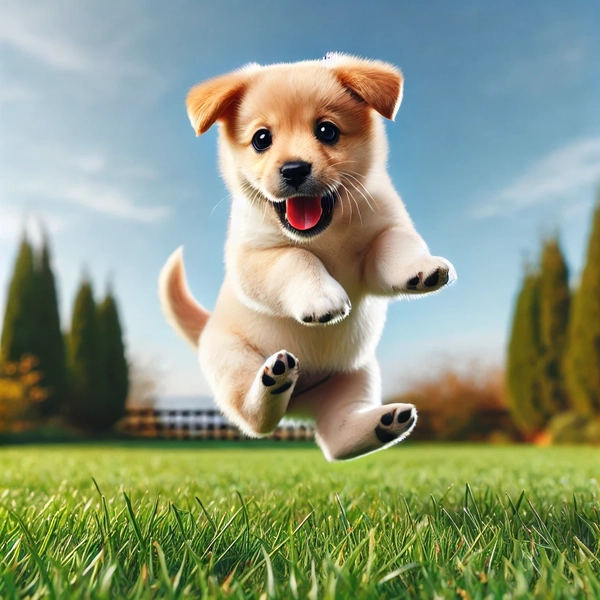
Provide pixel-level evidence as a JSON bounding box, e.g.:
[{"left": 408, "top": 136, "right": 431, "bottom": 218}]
[{"left": 325, "top": 54, "right": 404, "bottom": 121}]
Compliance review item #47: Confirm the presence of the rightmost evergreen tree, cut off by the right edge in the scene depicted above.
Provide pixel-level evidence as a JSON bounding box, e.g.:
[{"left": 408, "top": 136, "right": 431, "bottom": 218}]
[{"left": 566, "top": 197, "right": 600, "bottom": 414}]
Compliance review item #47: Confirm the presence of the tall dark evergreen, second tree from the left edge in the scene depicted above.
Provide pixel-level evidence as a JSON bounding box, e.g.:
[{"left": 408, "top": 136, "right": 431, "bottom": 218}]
[{"left": 31, "top": 237, "right": 67, "bottom": 417}]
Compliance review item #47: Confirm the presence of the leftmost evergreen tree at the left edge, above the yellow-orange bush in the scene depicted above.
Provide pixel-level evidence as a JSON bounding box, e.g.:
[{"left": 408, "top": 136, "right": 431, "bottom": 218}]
[{"left": 0, "top": 235, "right": 37, "bottom": 362}]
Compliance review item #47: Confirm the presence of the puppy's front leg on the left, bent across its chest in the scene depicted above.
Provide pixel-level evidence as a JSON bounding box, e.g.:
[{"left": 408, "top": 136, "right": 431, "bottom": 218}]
[{"left": 229, "top": 247, "right": 351, "bottom": 325}]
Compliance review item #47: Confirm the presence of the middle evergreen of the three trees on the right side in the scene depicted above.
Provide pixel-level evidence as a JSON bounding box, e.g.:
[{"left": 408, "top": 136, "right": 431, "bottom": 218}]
[{"left": 540, "top": 237, "right": 571, "bottom": 417}]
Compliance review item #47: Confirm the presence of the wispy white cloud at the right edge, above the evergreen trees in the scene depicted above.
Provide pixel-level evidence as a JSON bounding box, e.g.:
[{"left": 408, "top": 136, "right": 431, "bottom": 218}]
[{"left": 472, "top": 137, "right": 600, "bottom": 219}]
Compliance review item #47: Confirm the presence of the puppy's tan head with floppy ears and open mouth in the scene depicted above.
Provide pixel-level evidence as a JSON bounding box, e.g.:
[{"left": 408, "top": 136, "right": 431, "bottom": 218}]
[{"left": 187, "top": 54, "right": 402, "bottom": 240}]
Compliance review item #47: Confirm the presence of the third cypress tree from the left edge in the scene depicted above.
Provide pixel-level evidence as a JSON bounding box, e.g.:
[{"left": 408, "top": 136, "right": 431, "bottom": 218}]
[{"left": 67, "top": 279, "right": 106, "bottom": 433}]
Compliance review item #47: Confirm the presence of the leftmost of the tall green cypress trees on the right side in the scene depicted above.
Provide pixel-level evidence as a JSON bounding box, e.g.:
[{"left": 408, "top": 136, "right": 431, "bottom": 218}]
[{"left": 506, "top": 267, "right": 546, "bottom": 435}]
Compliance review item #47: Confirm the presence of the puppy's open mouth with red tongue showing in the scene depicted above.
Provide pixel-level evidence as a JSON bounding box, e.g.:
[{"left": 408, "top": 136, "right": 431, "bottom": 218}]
[{"left": 273, "top": 194, "right": 336, "bottom": 237}]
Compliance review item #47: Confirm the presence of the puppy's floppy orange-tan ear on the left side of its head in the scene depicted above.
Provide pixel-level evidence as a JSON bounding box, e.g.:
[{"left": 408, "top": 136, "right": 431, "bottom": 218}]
[{"left": 185, "top": 71, "right": 248, "bottom": 135}]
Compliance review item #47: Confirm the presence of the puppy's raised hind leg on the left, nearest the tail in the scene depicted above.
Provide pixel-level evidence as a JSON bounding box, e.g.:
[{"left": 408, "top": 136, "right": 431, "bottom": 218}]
[{"left": 200, "top": 331, "right": 300, "bottom": 437}]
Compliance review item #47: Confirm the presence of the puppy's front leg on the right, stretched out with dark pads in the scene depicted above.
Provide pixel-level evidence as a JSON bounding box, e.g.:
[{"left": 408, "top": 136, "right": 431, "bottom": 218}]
[{"left": 365, "top": 227, "right": 456, "bottom": 296}]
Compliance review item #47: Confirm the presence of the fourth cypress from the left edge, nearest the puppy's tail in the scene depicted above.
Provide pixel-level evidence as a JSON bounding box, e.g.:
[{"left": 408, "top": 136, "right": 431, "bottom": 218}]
[{"left": 98, "top": 290, "right": 129, "bottom": 429}]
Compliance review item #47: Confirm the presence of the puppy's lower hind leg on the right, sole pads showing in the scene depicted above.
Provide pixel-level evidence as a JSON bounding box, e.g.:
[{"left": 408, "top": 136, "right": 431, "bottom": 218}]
[{"left": 290, "top": 360, "right": 417, "bottom": 461}]
